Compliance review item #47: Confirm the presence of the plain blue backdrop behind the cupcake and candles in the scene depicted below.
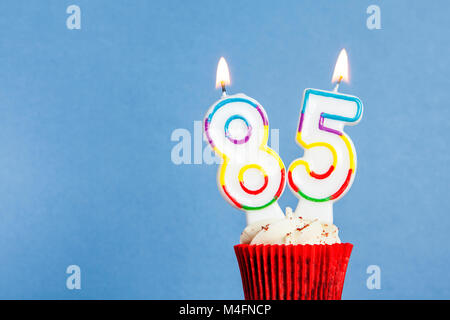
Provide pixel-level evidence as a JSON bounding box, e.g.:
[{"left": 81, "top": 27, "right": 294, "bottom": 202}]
[{"left": 0, "top": 0, "right": 450, "bottom": 299}]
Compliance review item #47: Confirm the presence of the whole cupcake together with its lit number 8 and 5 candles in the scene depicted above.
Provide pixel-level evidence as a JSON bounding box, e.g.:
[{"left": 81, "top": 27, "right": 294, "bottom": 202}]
[{"left": 203, "top": 57, "right": 362, "bottom": 300}]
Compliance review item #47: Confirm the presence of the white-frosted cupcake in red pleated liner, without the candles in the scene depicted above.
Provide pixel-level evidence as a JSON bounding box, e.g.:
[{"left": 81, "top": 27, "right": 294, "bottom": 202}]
[{"left": 234, "top": 208, "right": 353, "bottom": 300}]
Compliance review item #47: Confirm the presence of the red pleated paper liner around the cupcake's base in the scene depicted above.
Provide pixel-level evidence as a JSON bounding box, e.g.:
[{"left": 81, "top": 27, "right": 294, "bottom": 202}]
[{"left": 234, "top": 243, "right": 353, "bottom": 300}]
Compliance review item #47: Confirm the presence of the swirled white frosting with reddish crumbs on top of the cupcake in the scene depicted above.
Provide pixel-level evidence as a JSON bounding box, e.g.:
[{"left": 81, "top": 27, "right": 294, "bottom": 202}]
[{"left": 241, "top": 207, "right": 341, "bottom": 244}]
